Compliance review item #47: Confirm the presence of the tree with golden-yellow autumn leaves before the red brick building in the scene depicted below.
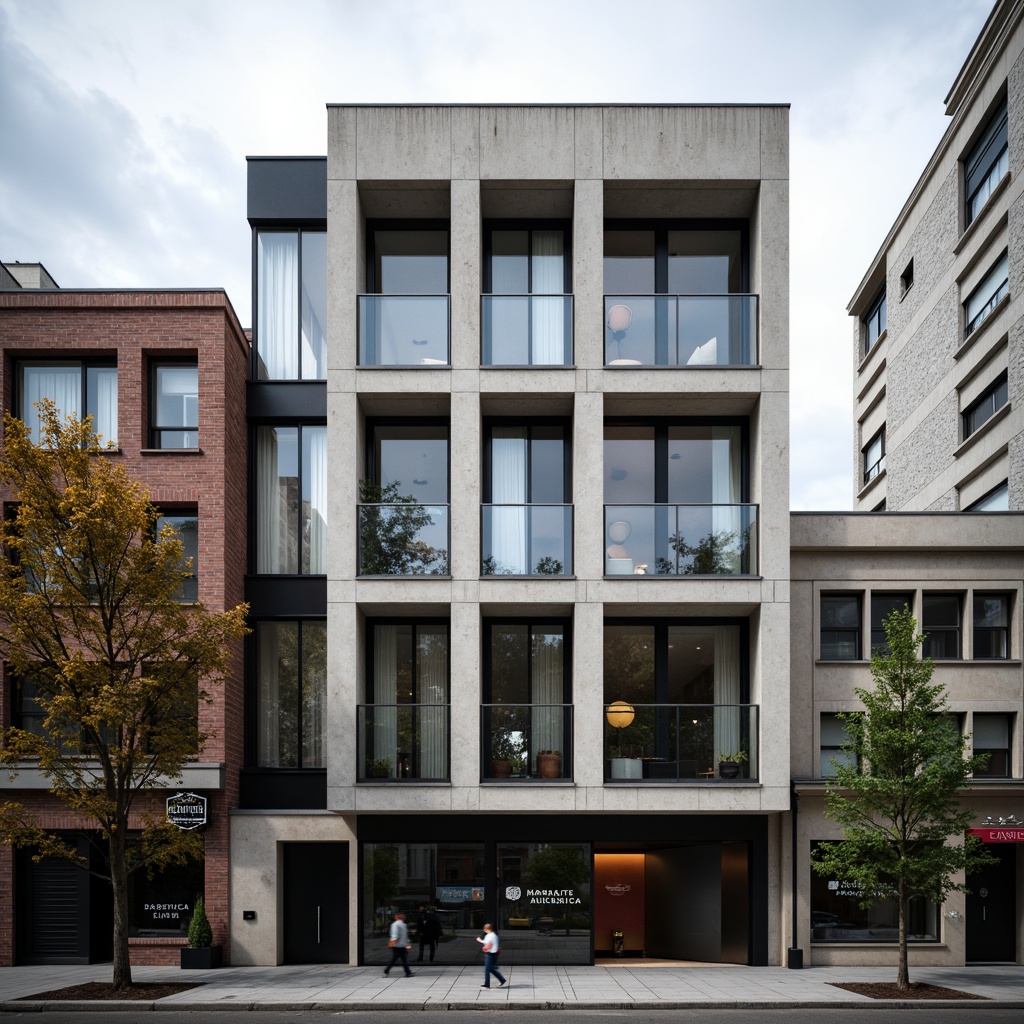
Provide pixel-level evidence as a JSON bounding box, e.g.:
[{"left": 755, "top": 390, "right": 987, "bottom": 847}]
[{"left": 0, "top": 401, "right": 246, "bottom": 989}]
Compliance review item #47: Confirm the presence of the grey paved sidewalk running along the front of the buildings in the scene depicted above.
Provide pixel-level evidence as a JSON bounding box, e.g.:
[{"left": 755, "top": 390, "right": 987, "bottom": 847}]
[{"left": 0, "top": 962, "right": 1024, "bottom": 1013}]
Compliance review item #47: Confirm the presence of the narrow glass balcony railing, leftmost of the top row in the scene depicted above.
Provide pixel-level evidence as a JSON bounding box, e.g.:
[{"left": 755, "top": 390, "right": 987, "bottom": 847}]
[{"left": 358, "top": 295, "right": 449, "bottom": 367}]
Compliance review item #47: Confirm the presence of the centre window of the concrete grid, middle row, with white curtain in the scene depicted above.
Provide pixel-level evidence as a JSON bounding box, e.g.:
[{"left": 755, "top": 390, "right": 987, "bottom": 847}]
[{"left": 481, "top": 423, "right": 572, "bottom": 575}]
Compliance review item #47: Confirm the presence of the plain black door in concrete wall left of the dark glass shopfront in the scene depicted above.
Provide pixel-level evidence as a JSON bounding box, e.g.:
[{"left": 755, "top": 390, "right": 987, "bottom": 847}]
[{"left": 284, "top": 843, "right": 348, "bottom": 964}]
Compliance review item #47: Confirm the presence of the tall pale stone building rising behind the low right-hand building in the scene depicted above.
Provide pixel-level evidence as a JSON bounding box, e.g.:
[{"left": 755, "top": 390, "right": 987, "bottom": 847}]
[{"left": 849, "top": 0, "right": 1024, "bottom": 511}]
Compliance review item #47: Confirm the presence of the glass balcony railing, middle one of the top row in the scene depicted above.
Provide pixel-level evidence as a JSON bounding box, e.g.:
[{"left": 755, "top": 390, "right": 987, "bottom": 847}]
[{"left": 480, "top": 295, "right": 572, "bottom": 367}]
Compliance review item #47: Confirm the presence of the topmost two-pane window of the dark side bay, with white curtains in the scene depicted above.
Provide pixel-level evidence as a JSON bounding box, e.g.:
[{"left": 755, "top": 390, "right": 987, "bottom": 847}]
[{"left": 256, "top": 230, "right": 327, "bottom": 380}]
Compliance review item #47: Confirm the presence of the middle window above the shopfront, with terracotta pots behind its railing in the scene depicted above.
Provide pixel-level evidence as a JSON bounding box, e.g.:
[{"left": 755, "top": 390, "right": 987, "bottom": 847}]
[{"left": 481, "top": 622, "right": 572, "bottom": 778}]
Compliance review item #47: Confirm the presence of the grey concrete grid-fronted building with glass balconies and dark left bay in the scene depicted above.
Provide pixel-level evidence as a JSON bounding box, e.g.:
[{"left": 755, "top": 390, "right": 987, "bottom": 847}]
[{"left": 231, "top": 105, "right": 790, "bottom": 964}]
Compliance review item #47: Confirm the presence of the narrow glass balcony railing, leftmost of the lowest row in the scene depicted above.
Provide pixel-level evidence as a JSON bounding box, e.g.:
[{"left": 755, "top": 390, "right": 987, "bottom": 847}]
[{"left": 356, "top": 703, "right": 451, "bottom": 782}]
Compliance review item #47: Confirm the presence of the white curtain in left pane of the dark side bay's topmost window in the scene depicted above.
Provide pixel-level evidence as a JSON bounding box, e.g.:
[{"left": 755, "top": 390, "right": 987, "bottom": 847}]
[{"left": 256, "top": 231, "right": 299, "bottom": 380}]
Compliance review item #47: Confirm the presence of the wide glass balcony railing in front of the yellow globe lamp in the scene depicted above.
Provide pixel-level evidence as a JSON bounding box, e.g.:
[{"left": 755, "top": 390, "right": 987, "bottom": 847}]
[{"left": 604, "top": 701, "right": 759, "bottom": 782}]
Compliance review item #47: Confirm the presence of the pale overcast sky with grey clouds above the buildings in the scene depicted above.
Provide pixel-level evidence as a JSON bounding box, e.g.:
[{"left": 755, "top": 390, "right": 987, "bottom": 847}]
[{"left": 0, "top": 0, "right": 991, "bottom": 509}]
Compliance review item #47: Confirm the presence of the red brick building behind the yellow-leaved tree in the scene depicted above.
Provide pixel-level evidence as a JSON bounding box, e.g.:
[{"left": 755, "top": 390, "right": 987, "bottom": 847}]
[{"left": 0, "top": 272, "right": 249, "bottom": 965}]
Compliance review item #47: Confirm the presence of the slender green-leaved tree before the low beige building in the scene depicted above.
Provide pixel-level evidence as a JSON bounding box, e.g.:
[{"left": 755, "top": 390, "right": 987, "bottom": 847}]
[{"left": 811, "top": 608, "right": 991, "bottom": 989}]
